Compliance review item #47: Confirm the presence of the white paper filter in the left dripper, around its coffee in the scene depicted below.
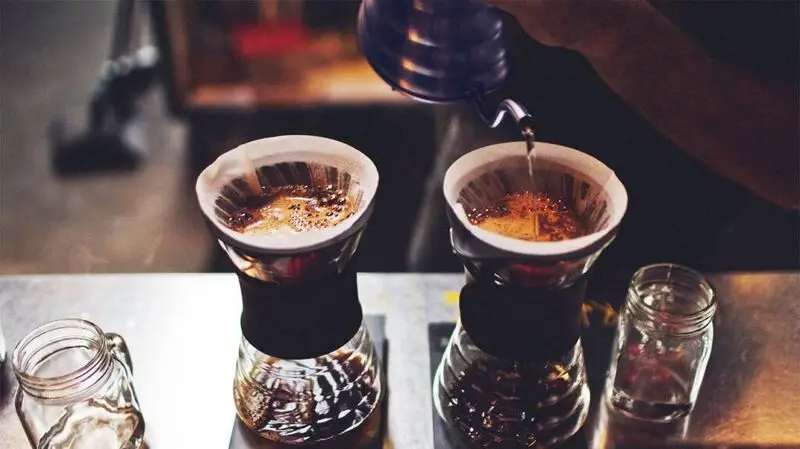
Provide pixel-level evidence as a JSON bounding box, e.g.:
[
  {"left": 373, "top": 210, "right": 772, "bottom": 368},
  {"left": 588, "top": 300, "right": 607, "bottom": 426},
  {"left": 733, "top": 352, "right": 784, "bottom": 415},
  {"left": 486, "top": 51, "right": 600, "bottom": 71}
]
[{"left": 195, "top": 135, "right": 378, "bottom": 251}]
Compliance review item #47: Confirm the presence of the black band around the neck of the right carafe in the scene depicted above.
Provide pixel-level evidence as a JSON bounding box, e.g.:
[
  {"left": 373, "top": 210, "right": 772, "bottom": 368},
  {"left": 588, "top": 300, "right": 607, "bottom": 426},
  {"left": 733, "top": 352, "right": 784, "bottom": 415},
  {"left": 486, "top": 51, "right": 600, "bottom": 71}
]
[{"left": 459, "top": 278, "right": 586, "bottom": 361}]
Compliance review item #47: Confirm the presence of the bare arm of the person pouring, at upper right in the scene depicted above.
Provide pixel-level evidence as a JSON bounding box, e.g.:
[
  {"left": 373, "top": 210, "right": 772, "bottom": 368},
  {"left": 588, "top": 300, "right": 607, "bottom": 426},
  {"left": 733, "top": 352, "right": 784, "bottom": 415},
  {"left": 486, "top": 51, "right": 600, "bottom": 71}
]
[{"left": 493, "top": 0, "right": 800, "bottom": 208}]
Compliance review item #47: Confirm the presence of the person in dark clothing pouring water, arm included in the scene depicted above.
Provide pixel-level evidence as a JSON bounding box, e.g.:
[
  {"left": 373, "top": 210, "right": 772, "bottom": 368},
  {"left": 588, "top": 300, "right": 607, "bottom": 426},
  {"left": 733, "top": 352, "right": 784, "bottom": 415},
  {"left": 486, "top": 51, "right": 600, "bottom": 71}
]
[{"left": 409, "top": 0, "right": 800, "bottom": 278}]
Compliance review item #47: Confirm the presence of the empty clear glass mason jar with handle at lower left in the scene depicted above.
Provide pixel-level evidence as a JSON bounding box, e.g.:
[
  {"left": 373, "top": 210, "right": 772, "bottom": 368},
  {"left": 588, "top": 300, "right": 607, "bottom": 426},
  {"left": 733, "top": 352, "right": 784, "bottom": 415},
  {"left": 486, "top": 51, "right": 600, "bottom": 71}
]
[{"left": 12, "top": 319, "right": 144, "bottom": 449}]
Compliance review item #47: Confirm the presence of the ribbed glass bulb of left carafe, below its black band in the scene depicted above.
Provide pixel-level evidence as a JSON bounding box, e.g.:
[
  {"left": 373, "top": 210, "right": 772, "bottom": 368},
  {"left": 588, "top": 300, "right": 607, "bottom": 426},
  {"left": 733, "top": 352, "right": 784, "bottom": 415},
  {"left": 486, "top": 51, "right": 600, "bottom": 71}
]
[{"left": 234, "top": 351, "right": 381, "bottom": 442}]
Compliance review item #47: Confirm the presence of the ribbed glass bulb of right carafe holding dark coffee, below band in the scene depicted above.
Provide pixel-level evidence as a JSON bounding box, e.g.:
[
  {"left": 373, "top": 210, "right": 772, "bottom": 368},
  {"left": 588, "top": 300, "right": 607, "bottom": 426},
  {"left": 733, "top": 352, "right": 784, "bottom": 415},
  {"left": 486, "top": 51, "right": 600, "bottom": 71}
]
[{"left": 438, "top": 360, "right": 587, "bottom": 449}]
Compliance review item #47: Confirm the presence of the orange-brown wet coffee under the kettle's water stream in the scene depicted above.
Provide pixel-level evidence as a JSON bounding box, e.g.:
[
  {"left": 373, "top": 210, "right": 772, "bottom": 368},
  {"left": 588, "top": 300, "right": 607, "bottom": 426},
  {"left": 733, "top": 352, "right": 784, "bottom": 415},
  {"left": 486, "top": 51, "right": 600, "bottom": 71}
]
[{"left": 467, "top": 192, "right": 590, "bottom": 242}]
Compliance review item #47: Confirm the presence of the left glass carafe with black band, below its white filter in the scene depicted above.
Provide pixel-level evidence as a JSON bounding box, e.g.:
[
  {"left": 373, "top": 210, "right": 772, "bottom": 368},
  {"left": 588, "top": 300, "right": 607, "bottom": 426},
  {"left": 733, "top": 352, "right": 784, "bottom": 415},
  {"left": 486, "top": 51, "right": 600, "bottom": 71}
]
[{"left": 223, "top": 238, "right": 384, "bottom": 442}]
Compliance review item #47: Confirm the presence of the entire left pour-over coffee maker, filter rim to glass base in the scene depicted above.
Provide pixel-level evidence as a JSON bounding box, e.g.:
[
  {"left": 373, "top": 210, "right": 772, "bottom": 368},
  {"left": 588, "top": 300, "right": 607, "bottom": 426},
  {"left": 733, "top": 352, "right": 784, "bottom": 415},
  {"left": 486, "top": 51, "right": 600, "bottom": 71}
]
[{"left": 196, "top": 136, "right": 384, "bottom": 448}]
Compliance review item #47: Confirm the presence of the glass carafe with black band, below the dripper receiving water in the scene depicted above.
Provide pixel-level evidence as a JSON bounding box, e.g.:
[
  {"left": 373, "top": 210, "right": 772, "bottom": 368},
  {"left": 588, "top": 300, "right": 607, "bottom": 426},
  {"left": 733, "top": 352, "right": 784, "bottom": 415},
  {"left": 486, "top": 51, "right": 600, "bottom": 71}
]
[{"left": 433, "top": 268, "right": 589, "bottom": 448}]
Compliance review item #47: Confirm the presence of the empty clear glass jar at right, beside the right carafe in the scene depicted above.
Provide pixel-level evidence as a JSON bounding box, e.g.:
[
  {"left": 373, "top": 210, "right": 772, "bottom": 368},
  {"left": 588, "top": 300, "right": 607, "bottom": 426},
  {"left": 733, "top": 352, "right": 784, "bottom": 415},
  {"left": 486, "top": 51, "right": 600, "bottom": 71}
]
[{"left": 606, "top": 264, "right": 717, "bottom": 422}]
